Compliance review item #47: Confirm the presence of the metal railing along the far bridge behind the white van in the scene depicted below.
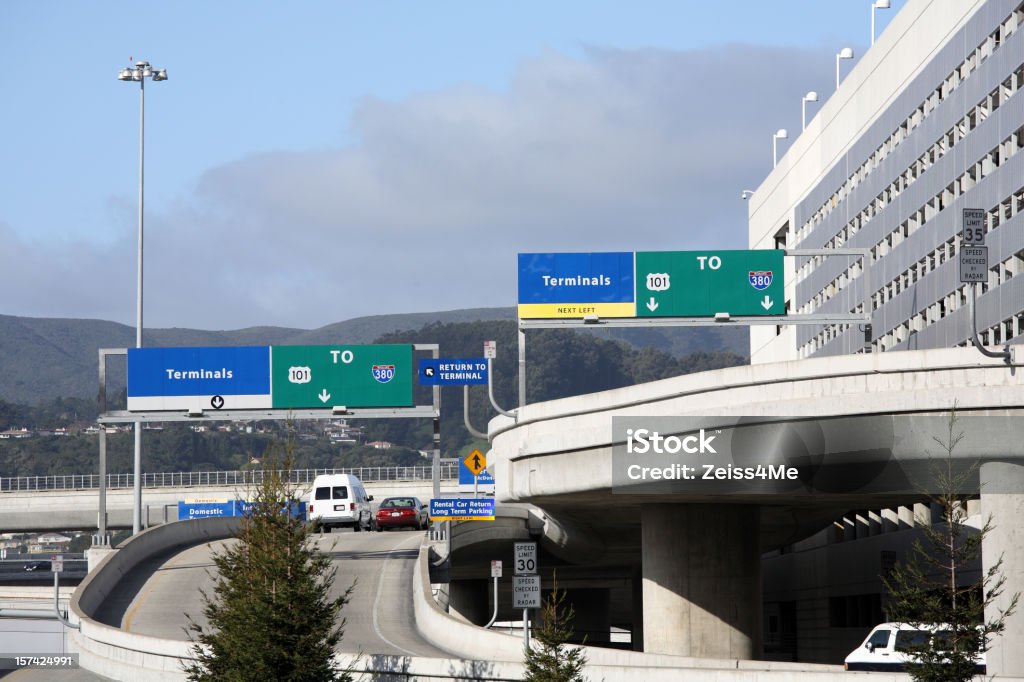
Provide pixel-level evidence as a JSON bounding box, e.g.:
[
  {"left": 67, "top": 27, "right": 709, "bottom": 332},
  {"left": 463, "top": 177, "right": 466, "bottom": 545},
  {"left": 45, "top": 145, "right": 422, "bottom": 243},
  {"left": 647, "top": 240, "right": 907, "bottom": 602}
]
[{"left": 0, "top": 458, "right": 459, "bottom": 493}]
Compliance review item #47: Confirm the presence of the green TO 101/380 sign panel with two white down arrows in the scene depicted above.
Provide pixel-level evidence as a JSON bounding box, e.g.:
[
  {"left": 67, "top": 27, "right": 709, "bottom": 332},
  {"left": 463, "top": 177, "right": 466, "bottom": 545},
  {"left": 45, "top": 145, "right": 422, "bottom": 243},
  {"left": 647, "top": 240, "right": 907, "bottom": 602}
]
[{"left": 635, "top": 250, "right": 785, "bottom": 317}]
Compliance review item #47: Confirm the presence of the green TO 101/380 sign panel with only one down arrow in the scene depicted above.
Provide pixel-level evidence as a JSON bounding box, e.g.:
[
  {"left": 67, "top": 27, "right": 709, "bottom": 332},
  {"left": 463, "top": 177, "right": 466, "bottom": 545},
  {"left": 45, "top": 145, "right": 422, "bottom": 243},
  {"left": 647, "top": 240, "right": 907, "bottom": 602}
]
[{"left": 270, "top": 344, "right": 415, "bottom": 410}]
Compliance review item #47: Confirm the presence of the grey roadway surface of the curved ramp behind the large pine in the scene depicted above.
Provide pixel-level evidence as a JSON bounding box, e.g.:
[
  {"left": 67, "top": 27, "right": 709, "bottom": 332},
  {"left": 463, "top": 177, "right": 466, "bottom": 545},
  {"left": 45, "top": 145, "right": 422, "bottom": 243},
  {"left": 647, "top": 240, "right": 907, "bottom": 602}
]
[{"left": 95, "top": 522, "right": 451, "bottom": 658}]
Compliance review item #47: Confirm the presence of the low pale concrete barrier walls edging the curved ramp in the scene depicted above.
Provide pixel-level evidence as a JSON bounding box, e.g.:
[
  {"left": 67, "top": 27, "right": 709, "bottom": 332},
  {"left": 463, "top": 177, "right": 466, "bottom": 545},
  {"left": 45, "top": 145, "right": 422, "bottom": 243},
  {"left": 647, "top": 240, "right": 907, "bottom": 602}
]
[{"left": 59, "top": 507, "right": 954, "bottom": 682}]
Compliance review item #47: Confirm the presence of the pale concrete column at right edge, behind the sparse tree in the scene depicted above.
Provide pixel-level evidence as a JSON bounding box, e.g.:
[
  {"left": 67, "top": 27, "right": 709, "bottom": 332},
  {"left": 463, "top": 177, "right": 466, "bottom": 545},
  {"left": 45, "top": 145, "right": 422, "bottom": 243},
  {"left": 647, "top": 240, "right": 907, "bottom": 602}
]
[{"left": 981, "top": 462, "right": 1024, "bottom": 677}]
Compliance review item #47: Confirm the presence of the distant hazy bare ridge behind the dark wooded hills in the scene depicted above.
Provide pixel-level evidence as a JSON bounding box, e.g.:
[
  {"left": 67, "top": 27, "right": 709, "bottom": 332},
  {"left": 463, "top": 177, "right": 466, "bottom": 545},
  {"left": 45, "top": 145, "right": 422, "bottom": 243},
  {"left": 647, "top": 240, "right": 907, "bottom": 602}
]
[{"left": 0, "top": 308, "right": 750, "bottom": 404}]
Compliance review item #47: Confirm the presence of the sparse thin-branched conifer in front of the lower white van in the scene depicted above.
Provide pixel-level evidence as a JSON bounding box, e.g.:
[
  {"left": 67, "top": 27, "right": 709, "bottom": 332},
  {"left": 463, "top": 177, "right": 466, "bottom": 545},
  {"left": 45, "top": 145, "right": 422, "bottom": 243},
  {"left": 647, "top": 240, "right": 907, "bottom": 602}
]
[{"left": 882, "top": 412, "right": 1020, "bottom": 682}]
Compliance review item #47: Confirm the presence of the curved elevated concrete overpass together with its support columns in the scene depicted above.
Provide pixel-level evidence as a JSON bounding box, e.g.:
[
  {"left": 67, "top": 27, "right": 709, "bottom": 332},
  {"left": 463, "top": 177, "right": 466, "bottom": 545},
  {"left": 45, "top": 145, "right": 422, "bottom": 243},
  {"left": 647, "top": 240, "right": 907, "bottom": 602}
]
[{"left": 483, "top": 349, "right": 1024, "bottom": 675}]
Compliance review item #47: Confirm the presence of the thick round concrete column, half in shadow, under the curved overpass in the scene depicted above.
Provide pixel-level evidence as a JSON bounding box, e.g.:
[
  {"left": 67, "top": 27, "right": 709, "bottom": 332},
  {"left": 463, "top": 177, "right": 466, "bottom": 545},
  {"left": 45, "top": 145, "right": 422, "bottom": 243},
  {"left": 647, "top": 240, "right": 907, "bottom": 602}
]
[{"left": 641, "top": 504, "right": 762, "bottom": 659}]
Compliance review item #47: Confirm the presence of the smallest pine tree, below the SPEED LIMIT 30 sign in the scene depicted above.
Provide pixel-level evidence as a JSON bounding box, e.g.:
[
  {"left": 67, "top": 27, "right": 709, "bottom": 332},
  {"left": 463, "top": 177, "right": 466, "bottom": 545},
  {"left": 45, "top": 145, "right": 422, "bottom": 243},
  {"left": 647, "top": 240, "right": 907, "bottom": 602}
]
[{"left": 523, "top": 577, "right": 587, "bottom": 682}]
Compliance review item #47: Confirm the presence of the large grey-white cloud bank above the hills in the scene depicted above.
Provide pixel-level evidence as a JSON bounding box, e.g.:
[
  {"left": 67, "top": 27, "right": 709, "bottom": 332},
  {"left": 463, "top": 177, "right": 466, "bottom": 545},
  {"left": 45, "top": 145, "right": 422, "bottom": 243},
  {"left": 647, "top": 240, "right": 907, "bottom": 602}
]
[{"left": 0, "top": 46, "right": 831, "bottom": 329}]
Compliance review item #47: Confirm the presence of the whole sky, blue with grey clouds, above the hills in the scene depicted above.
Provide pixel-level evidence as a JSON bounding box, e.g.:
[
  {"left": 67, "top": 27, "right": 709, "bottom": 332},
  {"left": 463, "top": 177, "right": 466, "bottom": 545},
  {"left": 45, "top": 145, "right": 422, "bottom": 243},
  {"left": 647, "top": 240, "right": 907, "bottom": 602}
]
[{"left": 0, "top": 0, "right": 903, "bottom": 329}]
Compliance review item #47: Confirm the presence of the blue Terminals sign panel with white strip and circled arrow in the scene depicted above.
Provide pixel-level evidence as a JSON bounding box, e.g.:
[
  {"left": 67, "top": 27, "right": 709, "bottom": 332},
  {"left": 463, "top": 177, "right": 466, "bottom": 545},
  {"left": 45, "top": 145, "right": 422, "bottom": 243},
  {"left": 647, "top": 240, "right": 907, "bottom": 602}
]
[{"left": 128, "top": 346, "right": 272, "bottom": 412}]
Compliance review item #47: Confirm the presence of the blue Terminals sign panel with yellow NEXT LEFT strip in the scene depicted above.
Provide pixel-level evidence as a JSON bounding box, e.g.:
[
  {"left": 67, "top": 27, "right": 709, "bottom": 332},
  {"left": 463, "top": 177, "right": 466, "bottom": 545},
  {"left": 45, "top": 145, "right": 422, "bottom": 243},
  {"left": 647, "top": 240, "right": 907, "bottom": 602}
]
[{"left": 518, "top": 251, "right": 636, "bottom": 319}]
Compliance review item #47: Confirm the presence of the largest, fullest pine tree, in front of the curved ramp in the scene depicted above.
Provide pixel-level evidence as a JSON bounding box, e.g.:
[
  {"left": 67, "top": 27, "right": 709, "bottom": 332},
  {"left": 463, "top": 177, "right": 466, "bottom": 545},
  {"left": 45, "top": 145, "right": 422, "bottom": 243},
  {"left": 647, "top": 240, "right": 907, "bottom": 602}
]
[{"left": 184, "top": 445, "right": 354, "bottom": 682}]
